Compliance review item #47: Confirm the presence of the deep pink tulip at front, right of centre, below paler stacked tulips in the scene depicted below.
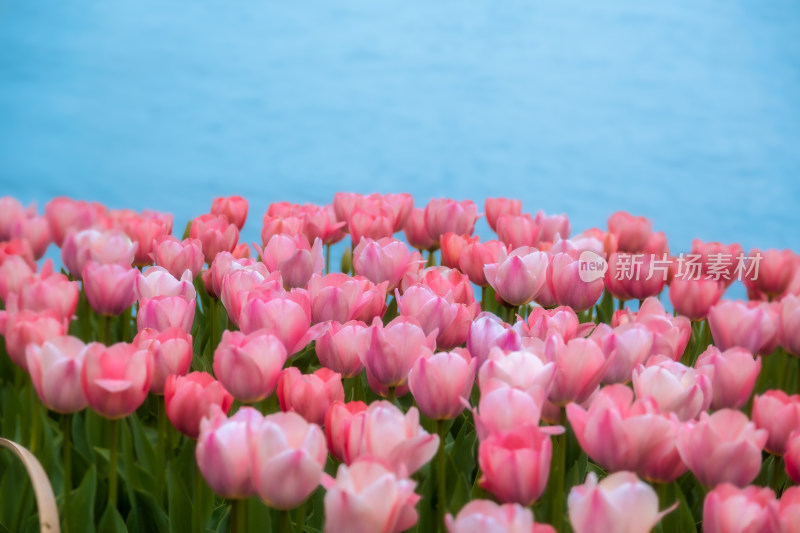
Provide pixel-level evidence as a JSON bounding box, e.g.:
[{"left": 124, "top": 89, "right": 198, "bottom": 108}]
[{"left": 478, "top": 424, "right": 553, "bottom": 506}]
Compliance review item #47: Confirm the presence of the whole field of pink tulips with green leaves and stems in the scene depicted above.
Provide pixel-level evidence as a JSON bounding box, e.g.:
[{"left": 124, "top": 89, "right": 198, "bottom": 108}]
[{"left": 0, "top": 193, "right": 800, "bottom": 533}]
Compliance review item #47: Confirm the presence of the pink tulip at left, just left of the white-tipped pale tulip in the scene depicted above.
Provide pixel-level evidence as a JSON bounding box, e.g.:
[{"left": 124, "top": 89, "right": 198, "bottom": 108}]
[{"left": 83, "top": 261, "right": 139, "bottom": 315}]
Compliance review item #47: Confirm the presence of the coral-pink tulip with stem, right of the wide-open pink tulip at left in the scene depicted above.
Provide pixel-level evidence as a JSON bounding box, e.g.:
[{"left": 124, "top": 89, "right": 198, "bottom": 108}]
[{"left": 133, "top": 327, "right": 193, "bottom": 394}]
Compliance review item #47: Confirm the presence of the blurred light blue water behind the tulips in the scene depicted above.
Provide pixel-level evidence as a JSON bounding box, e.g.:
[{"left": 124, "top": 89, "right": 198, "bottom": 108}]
[{"left": 0, "top": 0, "right": 800, "bottom": 252}]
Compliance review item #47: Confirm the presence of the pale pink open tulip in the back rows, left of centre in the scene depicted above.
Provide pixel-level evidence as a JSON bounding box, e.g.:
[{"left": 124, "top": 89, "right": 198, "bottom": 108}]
[{"left": 258, "top": 235, "right": 324, "bottom": 288}]
